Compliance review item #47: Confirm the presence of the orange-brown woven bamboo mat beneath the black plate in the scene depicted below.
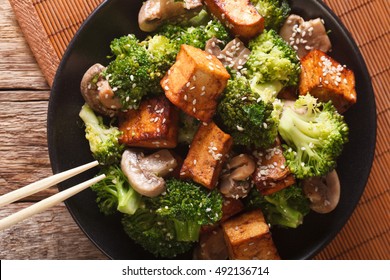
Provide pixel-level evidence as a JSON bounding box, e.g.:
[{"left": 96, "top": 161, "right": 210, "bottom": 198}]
[{"left": 10, "top": 0, "right": 390, "bottom": 259}]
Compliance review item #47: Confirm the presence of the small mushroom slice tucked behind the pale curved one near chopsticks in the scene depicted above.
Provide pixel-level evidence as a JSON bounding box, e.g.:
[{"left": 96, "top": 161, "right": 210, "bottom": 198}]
[{"left": 139, "top": 149, "right": 177, "bottom": 177}]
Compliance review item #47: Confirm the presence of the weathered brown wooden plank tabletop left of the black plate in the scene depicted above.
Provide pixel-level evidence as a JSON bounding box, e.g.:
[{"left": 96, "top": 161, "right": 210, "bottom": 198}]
[{"left": 0, "top": 0, "right": 106, "bottom": 259}]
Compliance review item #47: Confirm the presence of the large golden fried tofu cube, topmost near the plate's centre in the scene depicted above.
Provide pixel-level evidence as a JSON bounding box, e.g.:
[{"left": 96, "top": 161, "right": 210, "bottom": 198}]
[{"left": 160, "top": 45, "right": 230, "bottom": 122}]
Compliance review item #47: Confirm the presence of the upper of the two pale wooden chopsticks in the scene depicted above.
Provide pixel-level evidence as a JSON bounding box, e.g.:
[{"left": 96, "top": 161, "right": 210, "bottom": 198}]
[{"left": 0, "top": 161, "right": 99, "bottom": 207}]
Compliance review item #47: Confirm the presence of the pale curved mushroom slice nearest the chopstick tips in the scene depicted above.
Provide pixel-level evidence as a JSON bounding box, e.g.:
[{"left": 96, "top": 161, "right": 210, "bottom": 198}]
[{"left": 121, "top": 149, "right": 172, "bottom": 197}]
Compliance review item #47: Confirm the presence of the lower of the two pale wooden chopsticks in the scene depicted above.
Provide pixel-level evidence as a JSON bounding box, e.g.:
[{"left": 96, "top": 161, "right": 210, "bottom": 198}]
[{"left": 0, "top": 174, "right": 106, "bottom": 231}]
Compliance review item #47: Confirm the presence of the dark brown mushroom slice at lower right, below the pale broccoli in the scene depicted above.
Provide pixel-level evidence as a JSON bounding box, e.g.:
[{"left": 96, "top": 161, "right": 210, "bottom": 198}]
[{"left": 302, "top": 170, "right": 340, "bottom": 214}]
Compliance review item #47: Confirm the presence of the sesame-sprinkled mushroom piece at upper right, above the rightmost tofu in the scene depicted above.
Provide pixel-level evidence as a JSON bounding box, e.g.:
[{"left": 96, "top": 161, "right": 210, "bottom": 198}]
[{"left": 279, "top": 14, "right": 332, "bottom": 58}]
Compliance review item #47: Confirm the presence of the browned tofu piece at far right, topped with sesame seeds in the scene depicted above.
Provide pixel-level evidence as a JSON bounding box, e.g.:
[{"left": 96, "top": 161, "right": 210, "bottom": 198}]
[{"left": 299, "top": 50, "right": 356, "bottom": 113}]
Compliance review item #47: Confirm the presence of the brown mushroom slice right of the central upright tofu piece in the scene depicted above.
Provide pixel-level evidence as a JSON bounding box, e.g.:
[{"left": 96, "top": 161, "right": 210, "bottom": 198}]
[{"left": 219, "top": 154, "right": 256, "bottom": 199}]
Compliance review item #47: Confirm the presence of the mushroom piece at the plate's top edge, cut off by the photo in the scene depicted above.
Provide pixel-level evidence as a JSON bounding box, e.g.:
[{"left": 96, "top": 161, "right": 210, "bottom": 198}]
[{"left": 138, "top": 0, "right": 203, "bottom": 32}]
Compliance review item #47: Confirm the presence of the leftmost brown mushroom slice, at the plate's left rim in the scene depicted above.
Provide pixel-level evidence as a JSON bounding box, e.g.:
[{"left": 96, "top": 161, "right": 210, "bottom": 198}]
[{"left": 80, "top": 63, "right": 121, "bottom": 117}]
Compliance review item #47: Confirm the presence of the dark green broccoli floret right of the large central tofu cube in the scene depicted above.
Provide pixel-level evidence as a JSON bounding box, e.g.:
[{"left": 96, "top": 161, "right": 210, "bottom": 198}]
[{"left": 217, "top": 76, "right": 280, "bottom": 148}]
